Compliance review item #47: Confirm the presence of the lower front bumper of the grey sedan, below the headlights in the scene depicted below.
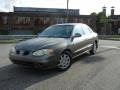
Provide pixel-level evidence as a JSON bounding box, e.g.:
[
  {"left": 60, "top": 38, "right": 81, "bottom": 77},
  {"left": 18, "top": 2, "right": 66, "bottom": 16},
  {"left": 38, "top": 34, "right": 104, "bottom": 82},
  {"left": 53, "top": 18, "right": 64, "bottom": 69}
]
[{"left": 9, "top": 53, "right": 59, "bottom": 69}]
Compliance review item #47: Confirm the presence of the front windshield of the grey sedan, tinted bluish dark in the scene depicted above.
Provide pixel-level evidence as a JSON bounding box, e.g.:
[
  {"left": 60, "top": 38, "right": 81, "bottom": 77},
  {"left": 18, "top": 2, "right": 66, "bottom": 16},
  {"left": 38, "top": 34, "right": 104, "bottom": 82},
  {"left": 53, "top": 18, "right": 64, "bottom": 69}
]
[{"left": 38, "top": 25, "right": 74, "bottom": 38}]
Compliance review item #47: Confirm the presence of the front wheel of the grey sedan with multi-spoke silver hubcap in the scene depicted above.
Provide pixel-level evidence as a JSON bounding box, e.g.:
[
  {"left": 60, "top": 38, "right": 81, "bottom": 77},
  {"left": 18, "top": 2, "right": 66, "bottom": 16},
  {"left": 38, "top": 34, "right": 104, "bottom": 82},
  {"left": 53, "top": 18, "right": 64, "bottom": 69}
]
[{"left": 58, "top": 53, "right": 71, "bottom": 71}]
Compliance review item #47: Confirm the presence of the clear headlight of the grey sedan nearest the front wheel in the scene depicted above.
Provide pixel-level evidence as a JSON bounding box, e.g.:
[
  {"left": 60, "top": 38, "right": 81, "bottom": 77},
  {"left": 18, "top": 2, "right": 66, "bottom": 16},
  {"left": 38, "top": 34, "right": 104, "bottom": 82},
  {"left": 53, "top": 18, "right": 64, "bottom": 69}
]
[{"left": 33, "top": 49, "right": 53, "bottom": 56}]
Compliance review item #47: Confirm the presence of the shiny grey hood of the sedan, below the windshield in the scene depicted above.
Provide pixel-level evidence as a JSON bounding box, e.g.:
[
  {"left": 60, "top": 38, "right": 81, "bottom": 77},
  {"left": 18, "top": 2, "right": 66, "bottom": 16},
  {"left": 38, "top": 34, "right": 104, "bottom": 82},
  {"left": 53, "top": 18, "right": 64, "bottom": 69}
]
[{"left": 15, "top": 38, "right": 66, "bottom": 51}]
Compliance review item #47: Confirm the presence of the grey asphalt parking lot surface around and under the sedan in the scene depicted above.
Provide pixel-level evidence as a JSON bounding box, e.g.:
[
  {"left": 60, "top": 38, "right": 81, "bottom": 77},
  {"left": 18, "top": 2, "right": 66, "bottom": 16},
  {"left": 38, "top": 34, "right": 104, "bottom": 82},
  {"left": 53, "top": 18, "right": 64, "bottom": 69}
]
[{"left": 0, "top": 40, "right": 120, "bottom": 90}]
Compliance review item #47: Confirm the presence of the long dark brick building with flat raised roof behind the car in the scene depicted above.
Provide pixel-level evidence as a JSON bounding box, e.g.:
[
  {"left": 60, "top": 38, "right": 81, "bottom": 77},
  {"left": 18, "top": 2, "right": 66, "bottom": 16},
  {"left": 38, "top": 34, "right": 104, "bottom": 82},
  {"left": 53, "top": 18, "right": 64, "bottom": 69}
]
[{"left": 0, "top": 7, "right": 96, "bottom": 35}]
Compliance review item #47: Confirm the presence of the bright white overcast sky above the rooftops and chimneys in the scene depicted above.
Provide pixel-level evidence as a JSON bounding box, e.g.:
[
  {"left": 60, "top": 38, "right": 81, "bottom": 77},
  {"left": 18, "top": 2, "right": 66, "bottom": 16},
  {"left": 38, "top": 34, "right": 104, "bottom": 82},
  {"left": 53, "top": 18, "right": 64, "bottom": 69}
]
[{"left": 0, "top": 0, "right": 120, "bottom": 15}]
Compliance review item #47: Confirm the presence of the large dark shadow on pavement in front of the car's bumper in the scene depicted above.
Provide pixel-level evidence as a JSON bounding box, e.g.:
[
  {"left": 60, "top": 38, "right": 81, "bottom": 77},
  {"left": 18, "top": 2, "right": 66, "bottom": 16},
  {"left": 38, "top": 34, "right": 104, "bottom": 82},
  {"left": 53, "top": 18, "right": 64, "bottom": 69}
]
[{"left": 0, "top": 64, "right": 63, "bottom": 90}]
